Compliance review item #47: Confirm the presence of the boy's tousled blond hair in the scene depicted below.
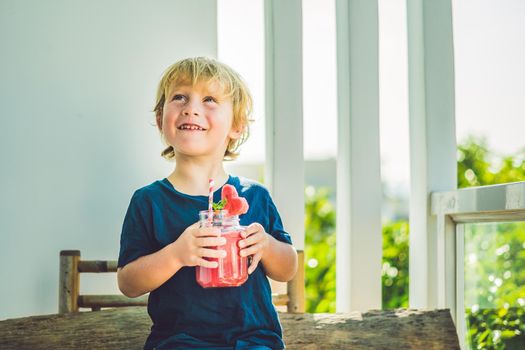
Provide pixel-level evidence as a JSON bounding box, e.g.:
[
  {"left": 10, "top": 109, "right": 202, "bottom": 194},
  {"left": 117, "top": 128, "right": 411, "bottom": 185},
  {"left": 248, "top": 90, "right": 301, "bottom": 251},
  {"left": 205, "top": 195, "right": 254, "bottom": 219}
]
[{"left": 153, "top": 57, "right": 253, "bottom": 160}]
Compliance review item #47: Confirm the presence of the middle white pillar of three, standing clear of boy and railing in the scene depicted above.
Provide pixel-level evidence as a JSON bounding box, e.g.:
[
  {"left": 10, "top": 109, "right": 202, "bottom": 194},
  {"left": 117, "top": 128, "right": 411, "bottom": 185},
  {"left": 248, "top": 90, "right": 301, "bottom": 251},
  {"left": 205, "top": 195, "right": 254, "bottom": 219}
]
[{"left": 336, "top": 0, "right": 382, "bottom": 312}]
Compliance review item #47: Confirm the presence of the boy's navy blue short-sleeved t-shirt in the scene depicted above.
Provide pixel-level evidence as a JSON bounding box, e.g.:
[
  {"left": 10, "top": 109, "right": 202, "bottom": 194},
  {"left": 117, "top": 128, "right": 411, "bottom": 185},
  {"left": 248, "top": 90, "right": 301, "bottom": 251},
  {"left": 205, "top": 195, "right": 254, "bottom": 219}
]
[{"left": 118, "top": 176, "right": 291, "bottom": 349}]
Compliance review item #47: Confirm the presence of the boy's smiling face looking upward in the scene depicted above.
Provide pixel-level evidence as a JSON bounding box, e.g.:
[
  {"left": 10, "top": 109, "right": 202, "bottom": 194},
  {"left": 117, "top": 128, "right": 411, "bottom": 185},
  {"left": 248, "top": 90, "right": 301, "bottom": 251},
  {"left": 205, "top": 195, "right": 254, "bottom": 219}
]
[{"left": 157, "top": 82, "right": 242, "bottom": 160}]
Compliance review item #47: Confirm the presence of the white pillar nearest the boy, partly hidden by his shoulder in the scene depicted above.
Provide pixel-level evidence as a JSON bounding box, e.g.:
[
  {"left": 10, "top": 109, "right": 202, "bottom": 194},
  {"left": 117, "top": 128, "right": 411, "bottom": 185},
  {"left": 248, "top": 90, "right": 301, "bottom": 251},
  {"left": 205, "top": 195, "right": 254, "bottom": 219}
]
[{"left": 265, "top": 0, "right": 304, "bottom": 250}]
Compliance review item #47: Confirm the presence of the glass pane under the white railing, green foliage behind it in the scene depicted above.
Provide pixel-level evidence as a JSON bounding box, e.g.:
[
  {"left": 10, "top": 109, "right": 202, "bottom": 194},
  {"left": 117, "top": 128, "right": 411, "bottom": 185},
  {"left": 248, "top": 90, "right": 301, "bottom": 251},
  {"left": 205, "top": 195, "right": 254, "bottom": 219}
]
[{"left": 463, "top": 222, "right": 525, "bottom": 349}]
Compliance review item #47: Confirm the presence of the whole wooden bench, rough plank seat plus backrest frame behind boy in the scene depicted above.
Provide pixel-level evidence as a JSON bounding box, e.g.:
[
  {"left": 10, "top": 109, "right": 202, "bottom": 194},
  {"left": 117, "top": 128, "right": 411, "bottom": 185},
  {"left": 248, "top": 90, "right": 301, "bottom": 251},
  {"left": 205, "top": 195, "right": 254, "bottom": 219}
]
[{"left": 0, "top": 251, "right": 459, "bottom": 350}]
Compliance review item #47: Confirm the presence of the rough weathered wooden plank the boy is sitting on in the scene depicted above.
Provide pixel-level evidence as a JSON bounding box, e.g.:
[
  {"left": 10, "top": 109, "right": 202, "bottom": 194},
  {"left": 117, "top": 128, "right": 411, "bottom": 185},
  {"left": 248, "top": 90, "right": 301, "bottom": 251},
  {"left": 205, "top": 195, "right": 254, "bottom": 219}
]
[{"left": 0, "top": 307, "right": 459, "bottom": 350}]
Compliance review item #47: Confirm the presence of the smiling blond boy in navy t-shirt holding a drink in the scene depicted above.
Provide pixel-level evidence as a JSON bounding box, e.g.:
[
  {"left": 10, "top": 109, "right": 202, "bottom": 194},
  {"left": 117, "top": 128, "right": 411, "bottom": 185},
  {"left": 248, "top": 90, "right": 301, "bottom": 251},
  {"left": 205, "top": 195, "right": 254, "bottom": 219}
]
[{"left": 117, "top": 57, "right": 297, "bottom": 349}]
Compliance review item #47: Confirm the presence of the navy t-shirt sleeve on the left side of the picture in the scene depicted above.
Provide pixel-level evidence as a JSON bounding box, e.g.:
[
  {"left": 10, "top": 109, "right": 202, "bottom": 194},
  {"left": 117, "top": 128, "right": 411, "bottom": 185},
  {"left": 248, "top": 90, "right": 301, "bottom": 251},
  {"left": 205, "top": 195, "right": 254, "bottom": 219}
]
[{"left": 118, "top": 191, "right": 157, "bottom": 267}]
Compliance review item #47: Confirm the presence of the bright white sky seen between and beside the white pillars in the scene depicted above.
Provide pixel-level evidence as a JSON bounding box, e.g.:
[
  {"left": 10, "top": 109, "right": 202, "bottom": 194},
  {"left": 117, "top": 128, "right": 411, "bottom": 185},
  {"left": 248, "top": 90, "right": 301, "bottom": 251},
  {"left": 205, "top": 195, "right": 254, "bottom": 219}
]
[{"left": 219, "top": 0, "right": 525, "bottom": 187}]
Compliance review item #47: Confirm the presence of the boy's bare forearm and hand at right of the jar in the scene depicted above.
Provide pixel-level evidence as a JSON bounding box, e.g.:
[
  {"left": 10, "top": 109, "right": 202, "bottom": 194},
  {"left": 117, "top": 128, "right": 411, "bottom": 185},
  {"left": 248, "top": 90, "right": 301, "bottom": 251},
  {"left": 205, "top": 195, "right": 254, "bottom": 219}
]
[{"left": 239, "top": 223, "right": 297, "bottom": 282}]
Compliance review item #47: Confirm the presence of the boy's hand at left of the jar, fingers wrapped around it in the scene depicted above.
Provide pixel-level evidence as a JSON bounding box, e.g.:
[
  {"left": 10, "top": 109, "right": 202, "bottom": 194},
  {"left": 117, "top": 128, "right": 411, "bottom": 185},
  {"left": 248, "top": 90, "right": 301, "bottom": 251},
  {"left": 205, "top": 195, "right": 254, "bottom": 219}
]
[{"left": 172, "top": 222, "right": 226, "bottom": 268}]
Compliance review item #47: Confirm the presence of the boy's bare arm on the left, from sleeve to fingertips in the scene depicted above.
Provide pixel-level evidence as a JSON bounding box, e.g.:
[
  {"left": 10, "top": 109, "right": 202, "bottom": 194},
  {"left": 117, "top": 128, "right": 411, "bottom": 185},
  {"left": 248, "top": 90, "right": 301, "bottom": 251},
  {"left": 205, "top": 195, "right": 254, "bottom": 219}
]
[{"left": 117, "top": 223, "right": 226, "bottom": 298}]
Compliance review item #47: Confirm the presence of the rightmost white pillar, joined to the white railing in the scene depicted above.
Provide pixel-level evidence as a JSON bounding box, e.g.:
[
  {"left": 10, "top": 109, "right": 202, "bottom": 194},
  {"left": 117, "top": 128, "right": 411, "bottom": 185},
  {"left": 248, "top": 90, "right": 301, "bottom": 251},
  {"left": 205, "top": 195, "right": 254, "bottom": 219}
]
[{"left": 407, "top": 0, "right": 457, "bottom": 308}]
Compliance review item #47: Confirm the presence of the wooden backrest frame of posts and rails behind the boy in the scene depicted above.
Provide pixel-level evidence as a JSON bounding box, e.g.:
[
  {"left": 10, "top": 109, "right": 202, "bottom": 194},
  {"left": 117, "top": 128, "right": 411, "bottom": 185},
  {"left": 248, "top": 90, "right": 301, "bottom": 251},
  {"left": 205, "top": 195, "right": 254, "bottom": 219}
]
[{"left": 58, "top": 250, "right": 305, "bottom": 314}]
